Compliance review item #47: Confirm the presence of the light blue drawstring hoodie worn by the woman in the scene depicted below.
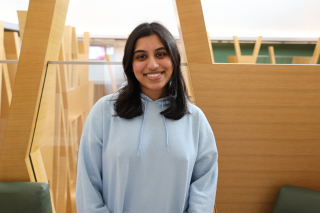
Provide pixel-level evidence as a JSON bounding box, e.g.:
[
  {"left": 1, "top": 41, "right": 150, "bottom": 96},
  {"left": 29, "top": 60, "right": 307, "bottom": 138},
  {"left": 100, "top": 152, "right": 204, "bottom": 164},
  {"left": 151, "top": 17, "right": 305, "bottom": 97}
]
[{"left": 76, "top": 83, "right": 218, "bottom": 213}]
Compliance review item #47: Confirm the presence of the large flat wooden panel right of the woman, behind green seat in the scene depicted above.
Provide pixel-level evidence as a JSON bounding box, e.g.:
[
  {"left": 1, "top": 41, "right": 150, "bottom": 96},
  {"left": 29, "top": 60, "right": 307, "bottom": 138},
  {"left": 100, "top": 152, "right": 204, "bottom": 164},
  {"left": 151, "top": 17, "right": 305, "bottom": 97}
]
[{"left": 189, "top": 64, "right": 320, "bottom": 213}]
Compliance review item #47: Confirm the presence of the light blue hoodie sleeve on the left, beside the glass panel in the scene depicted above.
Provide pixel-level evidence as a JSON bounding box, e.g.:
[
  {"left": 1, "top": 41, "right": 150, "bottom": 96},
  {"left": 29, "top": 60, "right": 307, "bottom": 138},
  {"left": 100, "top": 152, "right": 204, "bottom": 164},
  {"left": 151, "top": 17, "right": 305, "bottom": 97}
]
[{"left": 76, "top": 99, "right": 110, "bottom": 213}]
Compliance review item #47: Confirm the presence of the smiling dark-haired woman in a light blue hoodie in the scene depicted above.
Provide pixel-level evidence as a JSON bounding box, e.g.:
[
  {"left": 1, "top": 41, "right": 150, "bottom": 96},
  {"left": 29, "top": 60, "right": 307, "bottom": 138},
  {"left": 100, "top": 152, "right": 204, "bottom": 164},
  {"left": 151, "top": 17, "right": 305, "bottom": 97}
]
[{"left": 76, "top": 23, "right": 218, "bottom": 213}]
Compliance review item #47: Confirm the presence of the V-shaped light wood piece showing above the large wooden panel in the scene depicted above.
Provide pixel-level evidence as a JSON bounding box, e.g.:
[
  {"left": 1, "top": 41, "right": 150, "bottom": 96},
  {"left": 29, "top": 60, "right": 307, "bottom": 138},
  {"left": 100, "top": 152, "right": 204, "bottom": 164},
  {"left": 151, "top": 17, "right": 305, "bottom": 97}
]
[{"left": 228, "top": 36, "right": 262, "bottom": 64}]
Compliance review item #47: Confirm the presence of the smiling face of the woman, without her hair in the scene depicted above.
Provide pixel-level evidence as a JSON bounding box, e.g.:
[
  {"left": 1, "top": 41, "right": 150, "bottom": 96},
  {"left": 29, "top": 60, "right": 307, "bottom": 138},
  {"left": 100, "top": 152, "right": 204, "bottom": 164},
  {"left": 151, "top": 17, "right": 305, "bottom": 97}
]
[{"left": 132, "top": 34, "right": 173, "bottom": 100}]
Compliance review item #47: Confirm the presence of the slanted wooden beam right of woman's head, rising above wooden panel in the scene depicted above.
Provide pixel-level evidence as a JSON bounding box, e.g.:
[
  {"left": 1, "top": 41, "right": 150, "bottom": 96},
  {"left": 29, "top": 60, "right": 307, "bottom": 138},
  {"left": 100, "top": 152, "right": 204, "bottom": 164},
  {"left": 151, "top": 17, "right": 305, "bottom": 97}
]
[{"left": 173, "top": 0, "right": 213, "bottom": 64}]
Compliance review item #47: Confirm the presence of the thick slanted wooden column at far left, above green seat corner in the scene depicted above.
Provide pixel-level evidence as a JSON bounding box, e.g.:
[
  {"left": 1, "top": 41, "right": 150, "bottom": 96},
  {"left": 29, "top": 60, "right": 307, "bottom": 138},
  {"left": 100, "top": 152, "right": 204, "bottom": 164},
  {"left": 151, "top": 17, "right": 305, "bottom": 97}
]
[{"left": 0, "top": 0, "right": 69, "bottom": 181}]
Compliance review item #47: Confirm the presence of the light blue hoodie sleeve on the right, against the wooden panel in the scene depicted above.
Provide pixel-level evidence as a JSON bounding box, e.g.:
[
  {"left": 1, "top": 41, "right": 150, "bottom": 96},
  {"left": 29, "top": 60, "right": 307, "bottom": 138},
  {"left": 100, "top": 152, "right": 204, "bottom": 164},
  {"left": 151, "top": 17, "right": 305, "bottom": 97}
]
[{"left": 187, "top": 112, "right": 218, "bottom": 213}]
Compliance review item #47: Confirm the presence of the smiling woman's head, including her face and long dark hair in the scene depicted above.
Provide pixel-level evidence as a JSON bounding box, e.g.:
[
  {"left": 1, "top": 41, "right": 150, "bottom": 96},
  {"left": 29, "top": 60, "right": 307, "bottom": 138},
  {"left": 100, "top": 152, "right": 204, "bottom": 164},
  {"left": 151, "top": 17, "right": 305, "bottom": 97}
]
[{"left": 115, "top": 23, "right": 189, "bottom": 120}]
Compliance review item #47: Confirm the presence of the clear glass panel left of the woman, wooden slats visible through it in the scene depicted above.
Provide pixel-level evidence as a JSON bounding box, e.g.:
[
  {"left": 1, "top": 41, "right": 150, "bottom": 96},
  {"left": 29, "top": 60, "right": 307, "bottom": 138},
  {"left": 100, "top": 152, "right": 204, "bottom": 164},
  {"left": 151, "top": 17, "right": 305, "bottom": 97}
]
[{"left": 30, "top": 64, "right": 124, "bottom": 212}]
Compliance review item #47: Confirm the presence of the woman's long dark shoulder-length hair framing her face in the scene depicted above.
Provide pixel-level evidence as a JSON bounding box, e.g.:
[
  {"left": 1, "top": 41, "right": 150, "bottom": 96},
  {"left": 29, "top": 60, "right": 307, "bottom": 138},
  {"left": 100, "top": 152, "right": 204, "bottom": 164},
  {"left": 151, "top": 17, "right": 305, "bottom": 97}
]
[{"left": 114, "top": 22, "right": 189, "bottom": 120}]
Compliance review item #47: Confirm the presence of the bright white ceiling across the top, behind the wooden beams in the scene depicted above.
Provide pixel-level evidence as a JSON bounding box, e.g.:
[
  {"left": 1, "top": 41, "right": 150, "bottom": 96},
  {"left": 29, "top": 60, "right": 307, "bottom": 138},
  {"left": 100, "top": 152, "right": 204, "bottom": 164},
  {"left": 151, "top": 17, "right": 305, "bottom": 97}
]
[{"left": 0, "top": 0, "right": 320, "bottom": 40}]
